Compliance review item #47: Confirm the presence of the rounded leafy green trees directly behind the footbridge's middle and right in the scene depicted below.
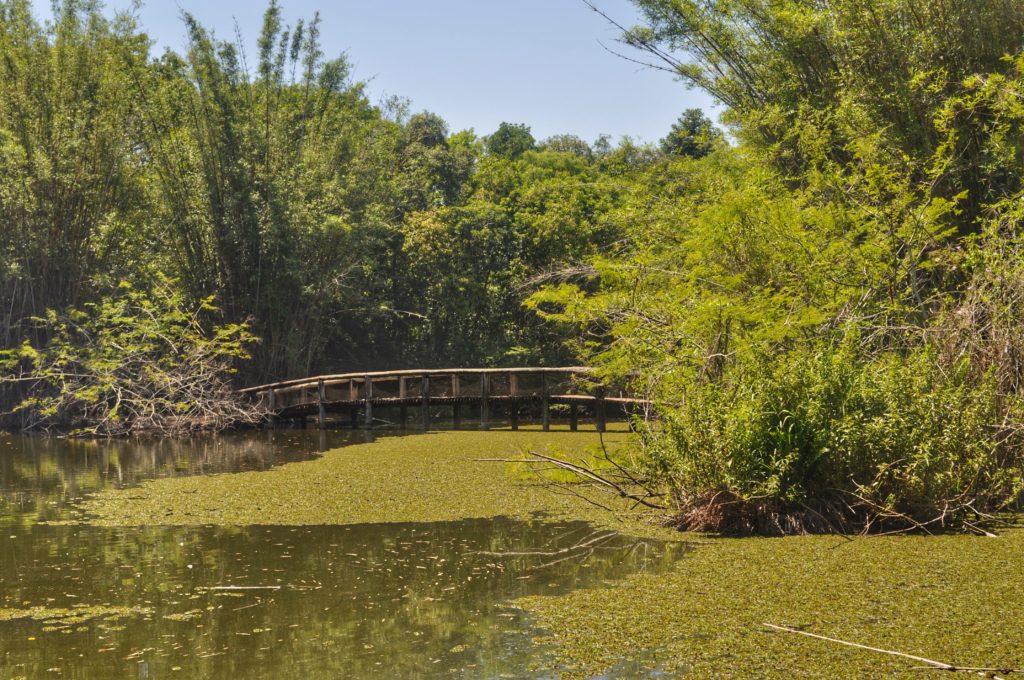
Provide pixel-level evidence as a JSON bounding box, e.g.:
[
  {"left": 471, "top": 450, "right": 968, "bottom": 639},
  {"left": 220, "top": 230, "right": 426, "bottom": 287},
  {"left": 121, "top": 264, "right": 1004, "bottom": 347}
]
[{"left": 403, "top": 145, "right": 617, "bottom": 365}]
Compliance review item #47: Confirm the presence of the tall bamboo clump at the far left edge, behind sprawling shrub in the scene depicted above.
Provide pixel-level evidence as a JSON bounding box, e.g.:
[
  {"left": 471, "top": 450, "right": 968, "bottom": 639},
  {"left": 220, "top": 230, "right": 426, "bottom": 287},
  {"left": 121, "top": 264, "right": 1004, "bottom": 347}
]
[{"left": 0, "top": 0, "right": 148, "bottom": 346}]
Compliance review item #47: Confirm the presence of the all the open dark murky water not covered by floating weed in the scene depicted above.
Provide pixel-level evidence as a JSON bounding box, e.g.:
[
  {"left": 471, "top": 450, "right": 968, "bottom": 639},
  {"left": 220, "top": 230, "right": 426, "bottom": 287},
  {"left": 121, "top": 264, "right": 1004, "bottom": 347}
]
[{"left": 0, "top": 430, "right": 685, "bottom": 680}]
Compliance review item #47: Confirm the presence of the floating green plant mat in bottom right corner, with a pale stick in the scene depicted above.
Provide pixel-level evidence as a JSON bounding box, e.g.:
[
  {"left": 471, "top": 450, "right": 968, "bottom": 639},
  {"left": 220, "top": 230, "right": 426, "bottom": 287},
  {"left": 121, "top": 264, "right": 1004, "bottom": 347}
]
[{"left": 520, "top": 529, "right": 1024, "bottom": 680}]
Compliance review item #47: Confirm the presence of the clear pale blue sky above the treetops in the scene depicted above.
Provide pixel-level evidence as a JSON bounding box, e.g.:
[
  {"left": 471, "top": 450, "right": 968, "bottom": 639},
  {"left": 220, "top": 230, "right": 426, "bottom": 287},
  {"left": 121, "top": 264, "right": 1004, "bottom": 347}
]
[{"left": 34, "top": 0, "right": 713, "bottom": 141}]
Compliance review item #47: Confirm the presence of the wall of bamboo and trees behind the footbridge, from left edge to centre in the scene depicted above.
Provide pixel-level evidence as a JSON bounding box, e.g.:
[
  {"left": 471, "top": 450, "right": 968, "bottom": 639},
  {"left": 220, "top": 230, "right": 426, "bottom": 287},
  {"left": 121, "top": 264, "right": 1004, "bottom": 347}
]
[{"left": 0, "top": 0, "right": 632, "bottom": 393}]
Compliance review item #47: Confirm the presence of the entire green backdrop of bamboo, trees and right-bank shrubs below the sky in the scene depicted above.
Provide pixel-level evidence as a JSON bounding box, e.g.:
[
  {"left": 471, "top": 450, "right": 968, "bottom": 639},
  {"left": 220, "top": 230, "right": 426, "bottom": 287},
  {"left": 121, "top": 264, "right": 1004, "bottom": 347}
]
[{"left": 0, "top": 0, "right": 1024, "bottom": 534}]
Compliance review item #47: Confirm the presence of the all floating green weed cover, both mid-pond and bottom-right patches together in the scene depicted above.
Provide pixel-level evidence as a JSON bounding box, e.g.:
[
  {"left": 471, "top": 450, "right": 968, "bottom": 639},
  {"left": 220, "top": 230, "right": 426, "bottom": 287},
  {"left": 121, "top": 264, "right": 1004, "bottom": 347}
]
[{"left": 74, "top": 432, "right": 1024, "bottom": 678}]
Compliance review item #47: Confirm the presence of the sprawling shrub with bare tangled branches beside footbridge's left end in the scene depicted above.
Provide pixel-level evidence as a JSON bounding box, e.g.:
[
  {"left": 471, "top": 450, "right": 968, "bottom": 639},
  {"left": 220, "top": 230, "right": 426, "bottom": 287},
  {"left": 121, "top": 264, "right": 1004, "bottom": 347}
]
[{"left": 0, "top": 280, "right": 260, "bottom": 435}]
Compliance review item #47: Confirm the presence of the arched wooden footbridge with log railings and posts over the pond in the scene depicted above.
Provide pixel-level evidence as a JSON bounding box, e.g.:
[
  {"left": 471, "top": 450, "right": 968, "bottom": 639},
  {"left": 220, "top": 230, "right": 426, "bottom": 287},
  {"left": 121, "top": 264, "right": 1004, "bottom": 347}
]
[{"left": 241, "top": 367, "right": 648, "bottom": 431}]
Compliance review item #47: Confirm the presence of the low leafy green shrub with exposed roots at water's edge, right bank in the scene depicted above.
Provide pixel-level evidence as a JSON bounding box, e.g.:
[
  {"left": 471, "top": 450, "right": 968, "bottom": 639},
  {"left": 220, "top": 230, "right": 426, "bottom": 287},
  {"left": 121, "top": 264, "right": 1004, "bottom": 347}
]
[{"left": 645, "top": 337, "right": 1024, "bottom": 535}]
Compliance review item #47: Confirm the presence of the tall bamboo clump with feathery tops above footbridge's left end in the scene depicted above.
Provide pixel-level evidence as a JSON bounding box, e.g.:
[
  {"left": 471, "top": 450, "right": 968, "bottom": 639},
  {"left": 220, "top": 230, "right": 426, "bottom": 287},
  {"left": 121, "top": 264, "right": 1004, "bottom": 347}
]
[{"left": 141, "top": 2, "right": 399, "bottom": 379}]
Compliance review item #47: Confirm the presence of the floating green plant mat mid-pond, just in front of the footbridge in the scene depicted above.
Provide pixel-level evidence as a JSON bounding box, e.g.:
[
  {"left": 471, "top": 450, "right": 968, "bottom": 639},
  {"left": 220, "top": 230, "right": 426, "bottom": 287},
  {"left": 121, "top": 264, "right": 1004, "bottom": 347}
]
[{"left": 82, "top": 431, "right": 647, "bottom": 526}]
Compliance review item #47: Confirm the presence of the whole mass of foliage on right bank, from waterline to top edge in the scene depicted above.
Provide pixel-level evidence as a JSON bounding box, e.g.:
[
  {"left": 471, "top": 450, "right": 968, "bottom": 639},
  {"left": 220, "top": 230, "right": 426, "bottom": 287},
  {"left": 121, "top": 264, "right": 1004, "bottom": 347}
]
[{"left": 534, "top": 0, "right": 1024, "bottom": 534}]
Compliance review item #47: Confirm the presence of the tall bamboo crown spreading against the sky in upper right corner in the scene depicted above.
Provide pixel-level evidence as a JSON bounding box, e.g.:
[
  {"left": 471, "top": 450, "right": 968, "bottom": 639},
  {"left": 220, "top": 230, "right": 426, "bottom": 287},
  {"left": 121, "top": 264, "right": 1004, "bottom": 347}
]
[{"left": 624, "top": 0, "right": 1024, "bottom": 233}]
